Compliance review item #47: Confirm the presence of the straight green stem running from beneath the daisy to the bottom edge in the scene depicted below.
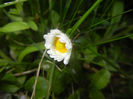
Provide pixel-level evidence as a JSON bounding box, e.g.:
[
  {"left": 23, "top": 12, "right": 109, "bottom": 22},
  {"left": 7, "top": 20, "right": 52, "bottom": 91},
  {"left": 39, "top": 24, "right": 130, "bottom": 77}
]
[{"left": 46, "top": 61, "right": 55, "bottom": 99}]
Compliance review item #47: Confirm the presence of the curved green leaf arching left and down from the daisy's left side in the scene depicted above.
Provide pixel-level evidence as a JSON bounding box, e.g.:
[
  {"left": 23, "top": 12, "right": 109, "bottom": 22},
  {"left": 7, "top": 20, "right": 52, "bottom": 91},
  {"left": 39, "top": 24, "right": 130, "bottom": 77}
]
[{"left": 18, "top": 42, "right": 44, "bottom": 62}]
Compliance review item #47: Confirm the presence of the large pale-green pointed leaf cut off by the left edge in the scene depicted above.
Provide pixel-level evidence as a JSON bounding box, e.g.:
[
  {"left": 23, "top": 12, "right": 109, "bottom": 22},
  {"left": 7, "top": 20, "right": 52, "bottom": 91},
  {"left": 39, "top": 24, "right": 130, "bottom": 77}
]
[{"left": 0, "top": 22, "right": 29, "bottom": 33}]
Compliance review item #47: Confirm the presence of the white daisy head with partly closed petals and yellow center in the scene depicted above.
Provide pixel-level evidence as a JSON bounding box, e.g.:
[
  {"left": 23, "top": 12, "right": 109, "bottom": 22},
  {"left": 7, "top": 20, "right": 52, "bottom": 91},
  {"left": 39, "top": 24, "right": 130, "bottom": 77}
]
[{"left": 43, "top": 29, "right": 72, "bottom": 65}]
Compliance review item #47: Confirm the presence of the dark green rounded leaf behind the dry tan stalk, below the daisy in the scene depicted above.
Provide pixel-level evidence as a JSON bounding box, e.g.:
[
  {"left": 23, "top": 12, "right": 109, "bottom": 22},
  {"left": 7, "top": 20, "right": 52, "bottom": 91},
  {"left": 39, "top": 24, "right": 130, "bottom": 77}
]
[{"left": 25, "top": 77, "right": 49, "bottom": 99}]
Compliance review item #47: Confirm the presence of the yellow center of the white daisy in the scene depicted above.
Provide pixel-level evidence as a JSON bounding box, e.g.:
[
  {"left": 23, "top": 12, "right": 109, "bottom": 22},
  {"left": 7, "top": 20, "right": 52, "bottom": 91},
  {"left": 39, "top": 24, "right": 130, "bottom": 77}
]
[{"left": 55, "top": 37, "right": 67, "bottom": 53}]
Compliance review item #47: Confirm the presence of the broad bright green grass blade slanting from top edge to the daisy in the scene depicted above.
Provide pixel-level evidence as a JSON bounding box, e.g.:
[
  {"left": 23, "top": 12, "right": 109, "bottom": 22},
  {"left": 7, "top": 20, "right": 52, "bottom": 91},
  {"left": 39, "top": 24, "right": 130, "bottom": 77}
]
[{"left": 70, "top": 0, "right": 102, "bottom": 37}]
